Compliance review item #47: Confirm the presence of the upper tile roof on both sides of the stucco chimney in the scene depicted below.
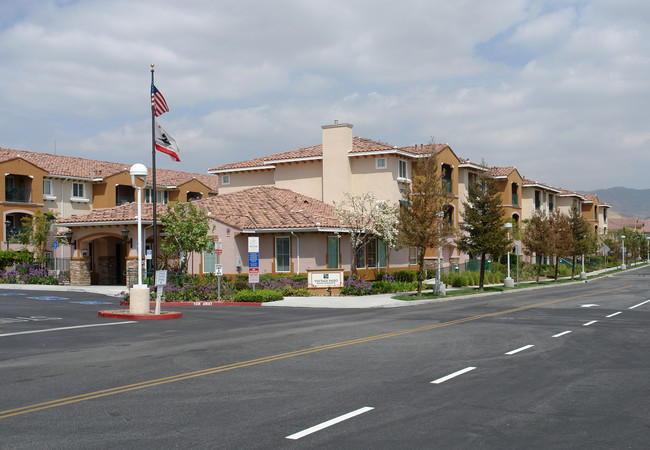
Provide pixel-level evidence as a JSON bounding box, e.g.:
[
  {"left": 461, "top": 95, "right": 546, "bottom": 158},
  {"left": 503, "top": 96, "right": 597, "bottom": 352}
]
[{"left": 208, "top": 136, "right": 449, "bottom": 172}]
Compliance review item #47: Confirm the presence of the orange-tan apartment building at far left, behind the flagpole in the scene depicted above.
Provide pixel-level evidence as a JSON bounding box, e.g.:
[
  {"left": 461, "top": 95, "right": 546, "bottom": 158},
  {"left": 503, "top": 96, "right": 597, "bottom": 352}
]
[{"left": 0, "top": 148, "right": 218, "bottom": 276}]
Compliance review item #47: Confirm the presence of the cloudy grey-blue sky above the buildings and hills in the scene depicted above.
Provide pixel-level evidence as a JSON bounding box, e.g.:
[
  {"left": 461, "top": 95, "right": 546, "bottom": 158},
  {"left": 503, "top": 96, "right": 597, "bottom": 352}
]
[{"left": 0, "top": 0, "right": 650, "bottom": 190}]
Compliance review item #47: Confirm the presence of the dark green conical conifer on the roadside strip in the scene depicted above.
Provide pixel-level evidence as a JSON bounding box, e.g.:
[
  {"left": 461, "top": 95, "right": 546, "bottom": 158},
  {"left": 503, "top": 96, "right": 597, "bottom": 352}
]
[{"left": 457, "top": 171, "right": 509, "bottom": 291}]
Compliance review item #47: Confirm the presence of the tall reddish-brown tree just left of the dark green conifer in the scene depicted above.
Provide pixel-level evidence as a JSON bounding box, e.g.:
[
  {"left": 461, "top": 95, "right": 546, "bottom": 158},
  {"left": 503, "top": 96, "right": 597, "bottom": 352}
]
[{"left": 399, "top": 146, "right": 453, "bottom": 297}]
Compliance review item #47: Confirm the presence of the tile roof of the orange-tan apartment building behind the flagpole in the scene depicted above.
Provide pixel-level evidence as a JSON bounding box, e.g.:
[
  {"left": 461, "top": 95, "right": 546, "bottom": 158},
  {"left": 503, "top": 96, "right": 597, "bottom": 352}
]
[{"left": 0, "top": 147, "right": 219, "bottom": 192}]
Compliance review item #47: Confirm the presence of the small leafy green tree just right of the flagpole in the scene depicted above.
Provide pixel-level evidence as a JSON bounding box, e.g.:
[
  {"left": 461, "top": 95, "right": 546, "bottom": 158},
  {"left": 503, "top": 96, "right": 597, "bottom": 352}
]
[{"left": 160, "top": 202, "right": 214, "bottom": 270}]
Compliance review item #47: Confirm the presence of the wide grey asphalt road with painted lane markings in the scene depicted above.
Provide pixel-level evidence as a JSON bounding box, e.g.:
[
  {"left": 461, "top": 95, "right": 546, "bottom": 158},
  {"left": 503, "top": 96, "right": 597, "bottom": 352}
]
[{"left": 0, "top": 268, "right": 650, "bottom": 449}]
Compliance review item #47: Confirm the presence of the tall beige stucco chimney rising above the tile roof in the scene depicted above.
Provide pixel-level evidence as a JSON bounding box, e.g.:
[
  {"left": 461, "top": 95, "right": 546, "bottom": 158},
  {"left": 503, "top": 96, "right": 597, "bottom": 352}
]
[{"left": 321, "top": 121, "right": 352, "bottom": 204}]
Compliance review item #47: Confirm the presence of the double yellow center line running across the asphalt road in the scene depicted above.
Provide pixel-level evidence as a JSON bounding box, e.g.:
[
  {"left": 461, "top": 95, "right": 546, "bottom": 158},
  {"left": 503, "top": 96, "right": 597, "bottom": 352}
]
[{"left": 0, "top": 285, "right": 632, "bottom": 419}]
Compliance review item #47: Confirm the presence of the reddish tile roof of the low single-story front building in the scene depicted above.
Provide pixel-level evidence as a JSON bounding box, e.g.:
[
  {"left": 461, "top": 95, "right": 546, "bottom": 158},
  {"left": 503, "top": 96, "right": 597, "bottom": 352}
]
[{"left": 58, "top": 187, "right": 340, "bottom": 230}]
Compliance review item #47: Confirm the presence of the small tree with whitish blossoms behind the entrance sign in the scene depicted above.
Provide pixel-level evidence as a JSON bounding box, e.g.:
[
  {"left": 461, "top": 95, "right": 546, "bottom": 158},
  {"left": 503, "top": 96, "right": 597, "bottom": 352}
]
[{"left": 334, "top": 192, "right": 397, "bottom": 274}]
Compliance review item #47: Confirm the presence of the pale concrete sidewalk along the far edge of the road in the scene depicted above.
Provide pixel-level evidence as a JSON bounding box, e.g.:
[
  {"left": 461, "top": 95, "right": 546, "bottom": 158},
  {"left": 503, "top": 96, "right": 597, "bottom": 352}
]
[{"left": 0, "top": 264, "right": 636, "bottom": 308}]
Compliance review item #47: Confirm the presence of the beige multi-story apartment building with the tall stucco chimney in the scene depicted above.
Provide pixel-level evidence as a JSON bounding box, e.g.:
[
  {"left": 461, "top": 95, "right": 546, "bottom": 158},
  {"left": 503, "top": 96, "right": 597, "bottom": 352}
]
[{"left": 208, "top": 123, "right": 461, "bottom": 268}]
